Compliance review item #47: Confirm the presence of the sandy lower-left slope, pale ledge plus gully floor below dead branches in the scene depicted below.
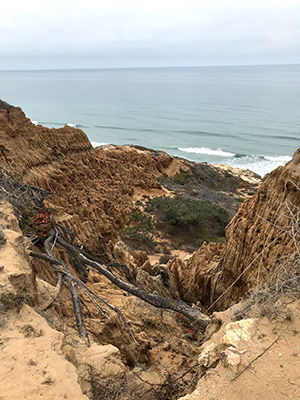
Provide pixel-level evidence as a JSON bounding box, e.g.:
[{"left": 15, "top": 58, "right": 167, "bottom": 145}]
[{"left": 0, "top": 201, "right": 205, "bottom": 400}]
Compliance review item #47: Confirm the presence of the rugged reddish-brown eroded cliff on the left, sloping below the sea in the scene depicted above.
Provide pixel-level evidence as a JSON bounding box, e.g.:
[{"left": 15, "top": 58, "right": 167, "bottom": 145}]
[{"left": 0, "top": 103, "right": 172, "bottom": 248}]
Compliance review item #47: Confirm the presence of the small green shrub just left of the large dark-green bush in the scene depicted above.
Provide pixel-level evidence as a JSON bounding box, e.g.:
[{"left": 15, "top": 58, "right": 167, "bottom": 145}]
[{"left": 121, "top": 211, "right": 155, "bottom": 243}]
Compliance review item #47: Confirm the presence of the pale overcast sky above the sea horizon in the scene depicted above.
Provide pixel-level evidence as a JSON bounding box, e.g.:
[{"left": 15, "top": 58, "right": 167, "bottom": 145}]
[{"left": 0, "top": 0, "right": 300, "bottom": 69}]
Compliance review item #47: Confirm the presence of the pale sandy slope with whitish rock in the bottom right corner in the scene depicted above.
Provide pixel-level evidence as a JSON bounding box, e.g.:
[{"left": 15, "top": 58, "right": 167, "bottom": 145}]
[{"left": 180, "top": 301, "right": 300, "bottom": 400}]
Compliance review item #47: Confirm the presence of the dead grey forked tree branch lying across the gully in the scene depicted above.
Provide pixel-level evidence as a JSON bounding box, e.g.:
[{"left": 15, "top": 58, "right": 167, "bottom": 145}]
[{"left": 30, "top": 225, "right": 210, "bottom": 344}]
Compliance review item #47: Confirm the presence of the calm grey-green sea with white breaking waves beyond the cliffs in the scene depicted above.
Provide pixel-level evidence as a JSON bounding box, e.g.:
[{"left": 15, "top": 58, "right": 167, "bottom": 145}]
[{"left": 0, "top": 65, "right": 300, "bottom": 175}]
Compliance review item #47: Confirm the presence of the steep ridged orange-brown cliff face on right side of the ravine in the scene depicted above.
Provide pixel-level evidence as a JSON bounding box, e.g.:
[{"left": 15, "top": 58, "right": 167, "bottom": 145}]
[{"left": 182, "top": 150, "right": 300, "bottom": 309}]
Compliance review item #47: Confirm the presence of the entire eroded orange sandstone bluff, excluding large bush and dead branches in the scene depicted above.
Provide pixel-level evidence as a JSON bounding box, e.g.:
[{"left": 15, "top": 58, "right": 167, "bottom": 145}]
[{"left": 0, "top": 102, "right": 300, "bottom": 400}]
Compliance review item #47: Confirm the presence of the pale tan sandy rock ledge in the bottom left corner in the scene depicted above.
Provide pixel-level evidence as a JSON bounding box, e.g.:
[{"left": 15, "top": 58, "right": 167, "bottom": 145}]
[{"left": 0, "top": 202, "right": 87, "bottom": 400}]
